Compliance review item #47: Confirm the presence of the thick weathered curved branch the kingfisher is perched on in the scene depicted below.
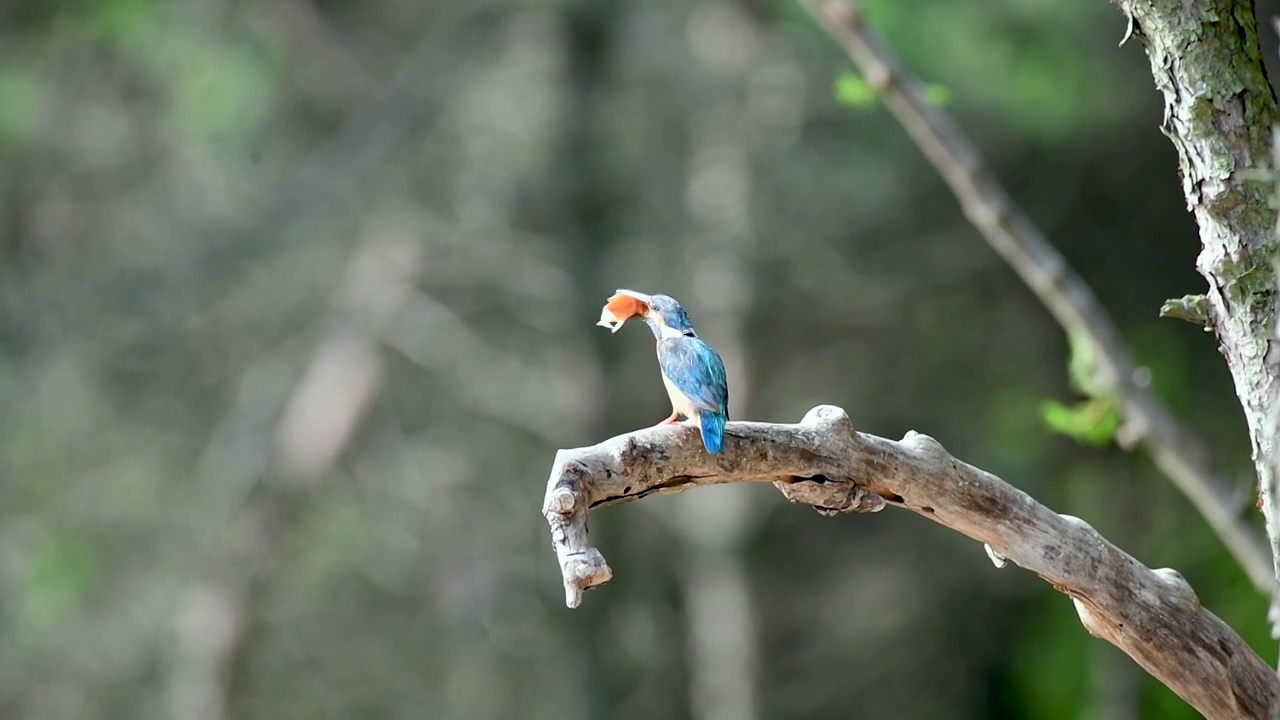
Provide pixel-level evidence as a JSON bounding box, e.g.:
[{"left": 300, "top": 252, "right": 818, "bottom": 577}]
[{"left": 543, "top": 405, "right": 1280, "bottom": 719}]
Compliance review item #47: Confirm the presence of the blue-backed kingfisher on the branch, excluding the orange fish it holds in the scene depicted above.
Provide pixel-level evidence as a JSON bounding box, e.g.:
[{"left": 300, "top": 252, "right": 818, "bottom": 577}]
[{"left": 641, "top": 289, "right": 728, "bottom": 455}]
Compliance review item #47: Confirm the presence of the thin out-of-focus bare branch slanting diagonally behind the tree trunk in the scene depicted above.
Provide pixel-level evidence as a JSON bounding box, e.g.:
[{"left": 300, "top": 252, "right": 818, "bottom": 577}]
[{"left": 800, "top": 0, "right": 1276, "bottom": 596}]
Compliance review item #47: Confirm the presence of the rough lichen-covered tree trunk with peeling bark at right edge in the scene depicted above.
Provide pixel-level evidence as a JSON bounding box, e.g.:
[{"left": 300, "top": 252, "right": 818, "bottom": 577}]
[{"left": 1117, "top": 0, "right": 1280, "bottom": 573}]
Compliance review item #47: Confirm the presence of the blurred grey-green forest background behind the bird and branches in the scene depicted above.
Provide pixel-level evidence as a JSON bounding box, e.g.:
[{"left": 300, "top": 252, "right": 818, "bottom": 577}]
[{"left": 0, "top": 0, "right": 1280, "bottom": 720}]
